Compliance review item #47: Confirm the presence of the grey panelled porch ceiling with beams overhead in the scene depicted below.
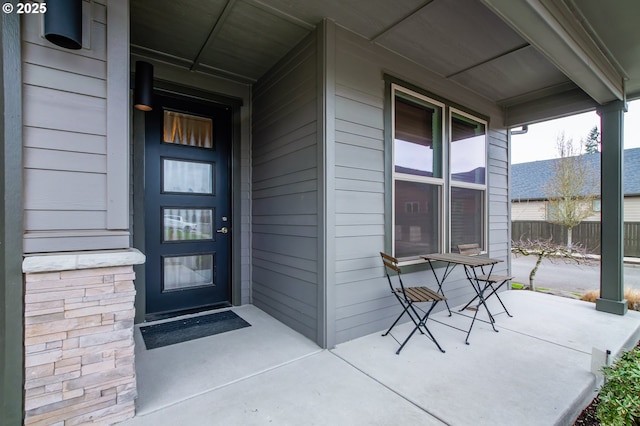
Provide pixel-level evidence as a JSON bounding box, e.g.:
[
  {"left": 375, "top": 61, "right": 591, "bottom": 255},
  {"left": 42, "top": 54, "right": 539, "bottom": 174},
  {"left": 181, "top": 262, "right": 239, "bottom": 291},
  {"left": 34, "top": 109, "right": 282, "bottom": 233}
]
[{"left": 131, "top": 0, "right": 640, "bottom": 125}]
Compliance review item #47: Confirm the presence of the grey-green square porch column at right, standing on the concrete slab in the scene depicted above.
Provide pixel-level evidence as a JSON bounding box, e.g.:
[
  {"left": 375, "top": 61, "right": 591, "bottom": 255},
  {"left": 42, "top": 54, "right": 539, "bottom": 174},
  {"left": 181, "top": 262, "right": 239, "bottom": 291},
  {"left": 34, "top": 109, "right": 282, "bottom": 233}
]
[{"left": 596, "top": 101, "right": 627, "bottom": 315}]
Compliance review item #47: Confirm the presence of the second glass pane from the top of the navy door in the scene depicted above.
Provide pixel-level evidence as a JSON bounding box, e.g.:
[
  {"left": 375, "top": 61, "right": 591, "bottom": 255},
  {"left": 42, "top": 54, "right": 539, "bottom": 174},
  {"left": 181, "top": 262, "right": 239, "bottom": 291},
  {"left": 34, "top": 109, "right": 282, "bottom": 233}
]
[{"left": 162, "top": 158, "right": 213, "bottom": 194}]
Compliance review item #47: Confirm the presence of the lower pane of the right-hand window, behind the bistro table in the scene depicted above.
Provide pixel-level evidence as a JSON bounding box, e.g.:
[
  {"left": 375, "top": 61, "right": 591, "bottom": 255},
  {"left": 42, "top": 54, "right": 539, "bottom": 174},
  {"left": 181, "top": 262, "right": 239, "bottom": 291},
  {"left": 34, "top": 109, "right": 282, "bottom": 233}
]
[{"left": 451, "top": 188, "right": 484, "bottom": 251}]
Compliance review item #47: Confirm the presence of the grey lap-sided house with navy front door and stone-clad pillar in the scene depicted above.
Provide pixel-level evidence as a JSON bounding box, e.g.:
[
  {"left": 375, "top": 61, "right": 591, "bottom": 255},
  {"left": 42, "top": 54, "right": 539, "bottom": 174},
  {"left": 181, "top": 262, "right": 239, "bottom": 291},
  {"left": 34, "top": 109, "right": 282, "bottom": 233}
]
[{"left": 0, "top": 0, "right": 640, "bottom": 425}]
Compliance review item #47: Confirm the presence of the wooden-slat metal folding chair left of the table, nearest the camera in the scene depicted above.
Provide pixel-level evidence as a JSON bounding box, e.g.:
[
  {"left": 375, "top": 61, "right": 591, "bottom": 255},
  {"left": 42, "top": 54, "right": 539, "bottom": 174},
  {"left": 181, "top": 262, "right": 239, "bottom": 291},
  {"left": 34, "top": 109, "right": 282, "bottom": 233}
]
[{"left": 380, "top": 252, "right": 447, "bottom": 355}]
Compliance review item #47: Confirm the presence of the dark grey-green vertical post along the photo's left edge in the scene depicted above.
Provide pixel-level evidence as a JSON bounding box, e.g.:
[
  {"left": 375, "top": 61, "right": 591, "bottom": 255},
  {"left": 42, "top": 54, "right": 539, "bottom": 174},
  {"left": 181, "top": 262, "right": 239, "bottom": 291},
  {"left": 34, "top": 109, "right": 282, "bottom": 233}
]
[{"left": 0, "top": 9, "right": 24, "bottom": 426}]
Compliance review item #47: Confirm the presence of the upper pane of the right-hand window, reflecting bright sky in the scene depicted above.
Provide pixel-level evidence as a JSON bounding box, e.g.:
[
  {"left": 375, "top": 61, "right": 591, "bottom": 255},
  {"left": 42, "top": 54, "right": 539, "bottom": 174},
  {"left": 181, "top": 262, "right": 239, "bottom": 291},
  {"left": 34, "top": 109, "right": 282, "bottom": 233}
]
[{"left": 451, "top": 113, "right": 487, "bottom": 185}]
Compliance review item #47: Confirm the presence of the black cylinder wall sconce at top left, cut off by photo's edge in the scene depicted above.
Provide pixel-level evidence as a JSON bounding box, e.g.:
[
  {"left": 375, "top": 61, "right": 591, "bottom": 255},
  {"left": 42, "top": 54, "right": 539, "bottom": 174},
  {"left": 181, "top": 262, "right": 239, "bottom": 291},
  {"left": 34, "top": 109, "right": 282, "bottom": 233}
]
[{"left": 44, "top": 0, "right": 82, "bottom": 50}]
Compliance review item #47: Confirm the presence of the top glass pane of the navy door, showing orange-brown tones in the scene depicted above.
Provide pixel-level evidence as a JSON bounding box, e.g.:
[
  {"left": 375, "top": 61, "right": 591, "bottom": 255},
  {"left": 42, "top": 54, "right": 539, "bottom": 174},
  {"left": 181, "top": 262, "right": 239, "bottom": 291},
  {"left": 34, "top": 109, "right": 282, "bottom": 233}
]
[{"left": 163, "top": 110, "right": 213, "bottom": 149}]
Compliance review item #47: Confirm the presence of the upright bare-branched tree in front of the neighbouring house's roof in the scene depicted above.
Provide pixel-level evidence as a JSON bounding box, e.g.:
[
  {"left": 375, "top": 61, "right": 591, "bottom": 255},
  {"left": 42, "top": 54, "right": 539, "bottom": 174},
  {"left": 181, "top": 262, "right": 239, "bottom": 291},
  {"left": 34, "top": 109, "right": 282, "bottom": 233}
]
[{"left": 544, "top": 129, "right": 600, "bottom": 248}]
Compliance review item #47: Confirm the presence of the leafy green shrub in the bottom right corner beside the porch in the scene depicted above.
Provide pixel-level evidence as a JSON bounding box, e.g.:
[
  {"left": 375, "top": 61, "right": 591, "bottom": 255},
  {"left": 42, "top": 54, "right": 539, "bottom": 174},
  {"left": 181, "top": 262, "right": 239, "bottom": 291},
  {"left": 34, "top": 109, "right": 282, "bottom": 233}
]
[{"left": 597, "top": 345, "right": 640, "bottom": 426}]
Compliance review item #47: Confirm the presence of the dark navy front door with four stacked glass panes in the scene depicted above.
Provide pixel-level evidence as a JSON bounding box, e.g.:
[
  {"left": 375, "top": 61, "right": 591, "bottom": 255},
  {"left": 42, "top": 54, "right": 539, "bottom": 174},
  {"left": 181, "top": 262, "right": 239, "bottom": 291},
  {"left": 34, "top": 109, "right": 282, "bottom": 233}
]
[{"left": 145, "top": 96, "right": 231, "bottom": 318}]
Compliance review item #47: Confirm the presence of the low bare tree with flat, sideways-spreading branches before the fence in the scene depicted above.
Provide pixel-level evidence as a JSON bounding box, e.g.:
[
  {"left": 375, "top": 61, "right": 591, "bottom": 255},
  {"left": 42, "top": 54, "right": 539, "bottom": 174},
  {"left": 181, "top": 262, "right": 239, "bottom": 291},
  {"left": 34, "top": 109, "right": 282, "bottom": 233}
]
[{"left": 511, "top": 237, "right": 590, "bottom": 291}]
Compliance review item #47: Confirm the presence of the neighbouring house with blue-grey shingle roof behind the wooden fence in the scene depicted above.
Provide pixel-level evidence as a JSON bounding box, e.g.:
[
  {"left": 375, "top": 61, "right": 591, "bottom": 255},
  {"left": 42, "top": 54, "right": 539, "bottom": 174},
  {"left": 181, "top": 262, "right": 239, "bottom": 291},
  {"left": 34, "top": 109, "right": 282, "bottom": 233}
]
[{"left": 511, "top": 148, "right": 640, "bottom": 222}]
